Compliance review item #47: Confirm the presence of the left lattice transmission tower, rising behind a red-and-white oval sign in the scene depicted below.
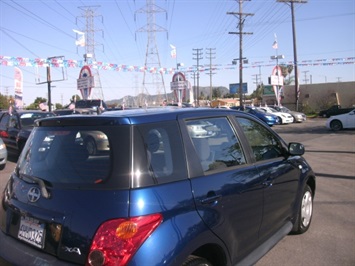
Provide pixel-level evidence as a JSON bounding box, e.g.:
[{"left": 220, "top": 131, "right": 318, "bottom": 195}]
[{"left": 77, "top": 6, "right": 104, "bottom": 100}]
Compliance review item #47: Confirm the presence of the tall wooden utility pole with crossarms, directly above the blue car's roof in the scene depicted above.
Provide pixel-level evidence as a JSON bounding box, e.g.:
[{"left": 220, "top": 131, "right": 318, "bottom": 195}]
[{"left": 227, "top": 0, "right": 254, "bottom": 107}]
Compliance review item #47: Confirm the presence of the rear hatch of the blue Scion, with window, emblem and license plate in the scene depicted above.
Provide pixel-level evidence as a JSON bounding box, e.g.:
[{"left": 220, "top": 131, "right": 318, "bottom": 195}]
[{"left": 0, "top": 119, "right": 131, "bottom": 264}]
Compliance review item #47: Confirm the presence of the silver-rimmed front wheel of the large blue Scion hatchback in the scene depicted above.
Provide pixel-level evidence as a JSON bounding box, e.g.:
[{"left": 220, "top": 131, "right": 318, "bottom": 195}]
[{"left": 292, "top": 185, "right": 313, "bottom": 234}]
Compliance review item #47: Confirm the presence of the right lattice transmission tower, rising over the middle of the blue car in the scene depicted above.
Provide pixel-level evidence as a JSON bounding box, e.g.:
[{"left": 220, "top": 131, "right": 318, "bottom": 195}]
[{"left": 136, "top": 0, "right": 167, "bottom": 105}]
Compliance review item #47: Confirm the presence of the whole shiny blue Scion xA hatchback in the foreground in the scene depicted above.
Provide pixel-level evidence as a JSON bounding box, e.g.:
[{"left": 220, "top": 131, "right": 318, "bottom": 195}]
[{"left": 0, "top": 107, "right": 316, "bottom": 266}]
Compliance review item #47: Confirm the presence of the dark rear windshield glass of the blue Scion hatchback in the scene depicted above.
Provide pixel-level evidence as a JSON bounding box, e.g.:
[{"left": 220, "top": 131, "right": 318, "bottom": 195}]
[{"left": 16, "top": 126, "right": 130, "bottom": 187}]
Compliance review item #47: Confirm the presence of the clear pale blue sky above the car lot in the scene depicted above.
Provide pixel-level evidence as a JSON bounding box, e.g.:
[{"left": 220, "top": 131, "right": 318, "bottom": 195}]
[{"left": 0, "top": 0, "right": 355, "bottom": 105}]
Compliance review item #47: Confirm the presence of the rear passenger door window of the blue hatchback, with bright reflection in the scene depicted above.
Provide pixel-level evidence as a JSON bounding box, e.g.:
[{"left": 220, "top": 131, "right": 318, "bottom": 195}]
[{"left": 186, "top": 117, "right": 246, "bottom": 172}]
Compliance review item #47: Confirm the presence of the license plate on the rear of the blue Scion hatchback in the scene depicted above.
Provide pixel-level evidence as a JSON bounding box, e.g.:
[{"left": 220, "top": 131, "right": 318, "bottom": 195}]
[{"left": 17, "top": 216, "right": 45, "bottom": 248}]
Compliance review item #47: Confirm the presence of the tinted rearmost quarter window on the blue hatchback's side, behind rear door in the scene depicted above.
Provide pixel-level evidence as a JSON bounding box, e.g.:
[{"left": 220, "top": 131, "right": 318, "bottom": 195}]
[{"left": 132, "top": 121, "right": 187, "bottom": 187}]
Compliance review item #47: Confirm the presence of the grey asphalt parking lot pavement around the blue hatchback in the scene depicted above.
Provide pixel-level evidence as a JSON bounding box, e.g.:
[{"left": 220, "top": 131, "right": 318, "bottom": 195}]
[{"left": 0, "top": 118, "right": 355, "bottom": 266}]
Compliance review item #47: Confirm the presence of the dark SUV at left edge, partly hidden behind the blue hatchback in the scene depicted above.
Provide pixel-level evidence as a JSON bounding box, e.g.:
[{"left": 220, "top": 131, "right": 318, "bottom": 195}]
[{"left": 0, "top": 110, "right": 55, "bottom": 155}]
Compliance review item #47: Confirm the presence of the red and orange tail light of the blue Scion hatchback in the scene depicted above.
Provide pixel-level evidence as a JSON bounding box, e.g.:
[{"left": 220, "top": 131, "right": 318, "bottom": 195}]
[{"left": 86, "top": 214, "right": 163, "bottom": 266}]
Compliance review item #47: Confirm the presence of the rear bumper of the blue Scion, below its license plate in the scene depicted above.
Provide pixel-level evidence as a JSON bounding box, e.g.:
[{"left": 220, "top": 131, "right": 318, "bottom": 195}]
[{"left": 0, "top": 231, "right": 77, "bottom": 266}]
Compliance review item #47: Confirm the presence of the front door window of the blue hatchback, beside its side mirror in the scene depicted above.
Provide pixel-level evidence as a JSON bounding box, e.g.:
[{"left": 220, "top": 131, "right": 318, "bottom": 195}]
[{"left": 237, "top": 117, "right": 283, "bottom": 161}]
